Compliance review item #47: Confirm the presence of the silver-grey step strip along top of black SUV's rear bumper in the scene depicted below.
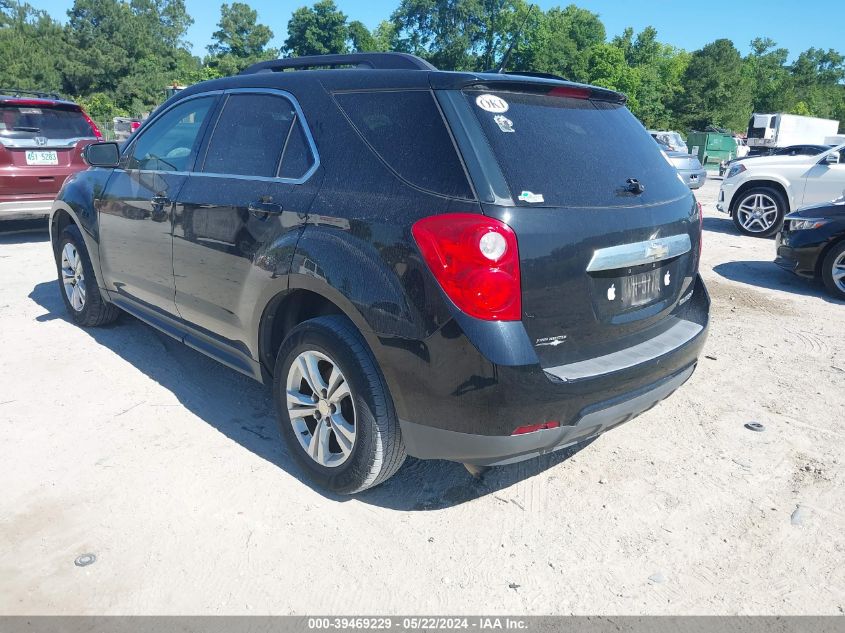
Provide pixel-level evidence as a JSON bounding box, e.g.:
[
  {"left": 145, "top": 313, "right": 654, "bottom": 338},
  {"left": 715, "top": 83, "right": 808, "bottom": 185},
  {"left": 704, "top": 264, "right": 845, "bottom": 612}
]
[{"left": 545, "top": 319, "right": 704, "bottom": 381}]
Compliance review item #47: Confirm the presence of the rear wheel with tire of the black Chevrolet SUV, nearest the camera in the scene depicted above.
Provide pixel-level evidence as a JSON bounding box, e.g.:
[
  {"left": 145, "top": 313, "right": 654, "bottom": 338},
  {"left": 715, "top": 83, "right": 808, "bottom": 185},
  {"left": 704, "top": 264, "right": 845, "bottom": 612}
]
[{"left": 273, "top": 316, "right": 405, "bottom": 494}]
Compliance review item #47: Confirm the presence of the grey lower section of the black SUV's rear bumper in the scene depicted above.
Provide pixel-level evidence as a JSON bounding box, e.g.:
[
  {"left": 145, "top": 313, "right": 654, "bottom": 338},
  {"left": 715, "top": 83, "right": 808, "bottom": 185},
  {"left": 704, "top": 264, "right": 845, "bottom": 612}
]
[{"left": 400, "top": 365, "right": 695, "bottom": 466}]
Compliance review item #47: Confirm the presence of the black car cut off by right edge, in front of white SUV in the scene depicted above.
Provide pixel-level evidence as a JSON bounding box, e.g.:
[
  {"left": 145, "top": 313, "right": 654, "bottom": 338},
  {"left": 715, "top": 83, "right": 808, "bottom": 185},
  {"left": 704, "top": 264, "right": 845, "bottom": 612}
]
[{"left": 775, "top": 198, "right": 845, "bottom": 299}]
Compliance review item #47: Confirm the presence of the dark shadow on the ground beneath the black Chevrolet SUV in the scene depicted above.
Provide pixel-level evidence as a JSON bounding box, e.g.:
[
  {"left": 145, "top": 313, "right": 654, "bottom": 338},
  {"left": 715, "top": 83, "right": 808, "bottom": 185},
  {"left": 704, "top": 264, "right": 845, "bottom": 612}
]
[{"left": 29, "top": 282, "right": 589, "bottom": 511}]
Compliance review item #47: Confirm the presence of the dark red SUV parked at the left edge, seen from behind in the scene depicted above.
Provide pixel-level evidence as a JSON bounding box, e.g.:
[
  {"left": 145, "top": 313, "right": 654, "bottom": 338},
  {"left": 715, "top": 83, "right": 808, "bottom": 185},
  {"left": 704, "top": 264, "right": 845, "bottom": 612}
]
[{"left": 0, "top": 88, "right": 102, "bottom": 219}]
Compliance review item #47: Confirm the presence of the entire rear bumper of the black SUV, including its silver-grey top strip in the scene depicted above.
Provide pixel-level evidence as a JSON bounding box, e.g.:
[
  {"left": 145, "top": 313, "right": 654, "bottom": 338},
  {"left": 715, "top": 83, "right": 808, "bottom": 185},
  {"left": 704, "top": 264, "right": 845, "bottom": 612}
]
[{"left": 371, "top": 276, "right": 710, "bottom": 465}]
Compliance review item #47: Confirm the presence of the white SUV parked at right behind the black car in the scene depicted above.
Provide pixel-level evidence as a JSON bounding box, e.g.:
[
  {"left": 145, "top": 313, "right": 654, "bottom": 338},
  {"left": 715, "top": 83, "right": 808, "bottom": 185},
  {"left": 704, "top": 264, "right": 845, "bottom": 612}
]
[{"left": 716, "top": 145, "right": 845, "bottom": 237}]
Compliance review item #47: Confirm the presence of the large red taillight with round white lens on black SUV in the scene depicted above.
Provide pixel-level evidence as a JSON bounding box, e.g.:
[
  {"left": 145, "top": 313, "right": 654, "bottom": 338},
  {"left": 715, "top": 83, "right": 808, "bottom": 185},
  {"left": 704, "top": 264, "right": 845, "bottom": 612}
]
[{"left": 411, "top": 213, "right": 522, "bottom": 321}]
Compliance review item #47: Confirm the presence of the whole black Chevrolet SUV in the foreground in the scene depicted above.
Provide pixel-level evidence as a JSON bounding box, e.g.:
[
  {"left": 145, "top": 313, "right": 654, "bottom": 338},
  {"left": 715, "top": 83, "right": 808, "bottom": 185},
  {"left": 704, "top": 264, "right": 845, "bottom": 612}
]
[{"left": 50, "top": 54, "right": 709, "bottom": 493}]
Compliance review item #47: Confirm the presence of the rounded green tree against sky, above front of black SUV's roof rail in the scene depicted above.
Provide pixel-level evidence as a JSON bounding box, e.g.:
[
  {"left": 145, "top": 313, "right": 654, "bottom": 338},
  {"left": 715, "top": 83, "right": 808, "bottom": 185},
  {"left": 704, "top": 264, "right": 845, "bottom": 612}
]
[{"left": 284, "top": 0, "right": 348, "bottom": 56}]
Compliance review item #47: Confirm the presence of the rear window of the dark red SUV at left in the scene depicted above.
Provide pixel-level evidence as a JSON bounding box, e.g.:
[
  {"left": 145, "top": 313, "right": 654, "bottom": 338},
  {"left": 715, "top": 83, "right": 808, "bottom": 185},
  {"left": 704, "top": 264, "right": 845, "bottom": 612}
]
[{"left": 0, "top": 105, "right": 94, "bottom": 139}]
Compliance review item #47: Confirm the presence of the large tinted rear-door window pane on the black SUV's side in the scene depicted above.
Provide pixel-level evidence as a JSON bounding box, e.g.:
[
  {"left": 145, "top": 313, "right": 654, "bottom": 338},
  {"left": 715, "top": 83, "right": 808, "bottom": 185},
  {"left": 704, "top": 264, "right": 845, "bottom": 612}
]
[{"left": 202, "top": 94, "right": 296, "bottom": 178}]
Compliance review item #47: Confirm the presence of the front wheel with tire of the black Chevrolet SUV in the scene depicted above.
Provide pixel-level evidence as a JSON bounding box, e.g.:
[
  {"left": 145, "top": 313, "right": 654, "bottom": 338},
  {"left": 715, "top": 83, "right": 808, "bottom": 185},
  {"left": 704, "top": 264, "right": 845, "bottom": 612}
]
[{"left": 56, "top": 224, "right": 120, "bottom": 327}]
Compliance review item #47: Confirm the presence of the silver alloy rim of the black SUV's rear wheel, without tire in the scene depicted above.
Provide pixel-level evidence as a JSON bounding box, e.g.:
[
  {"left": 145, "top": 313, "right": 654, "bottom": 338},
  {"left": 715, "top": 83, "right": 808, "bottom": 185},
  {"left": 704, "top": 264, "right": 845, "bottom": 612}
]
[{"left": 286, "top": 350, "right": 357, "bottom": 468}]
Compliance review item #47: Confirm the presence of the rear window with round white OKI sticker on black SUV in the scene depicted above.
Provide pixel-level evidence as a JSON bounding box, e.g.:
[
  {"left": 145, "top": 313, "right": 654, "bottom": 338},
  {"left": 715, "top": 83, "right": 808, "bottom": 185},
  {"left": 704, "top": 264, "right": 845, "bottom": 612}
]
[{"left": 465, "top": 91, "right": 689, "bottom": 208}]
